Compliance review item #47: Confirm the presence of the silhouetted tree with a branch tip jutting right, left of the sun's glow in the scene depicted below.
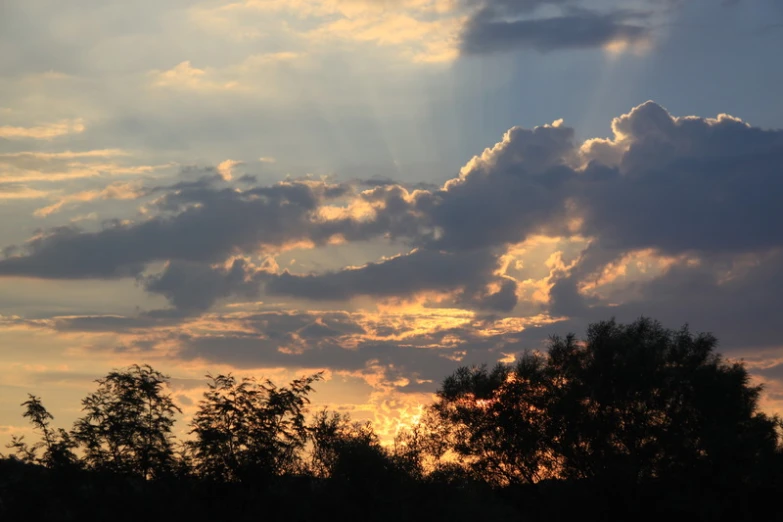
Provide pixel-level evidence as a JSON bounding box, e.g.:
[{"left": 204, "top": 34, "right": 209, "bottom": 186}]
[{"left": 189, "top": 373, "right": 322, "bottom": 482}]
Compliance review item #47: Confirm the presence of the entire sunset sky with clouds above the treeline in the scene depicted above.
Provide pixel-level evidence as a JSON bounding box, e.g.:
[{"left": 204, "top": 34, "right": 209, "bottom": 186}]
[{"left": 0, "top": 0, "right": 783, "bottom": 443}]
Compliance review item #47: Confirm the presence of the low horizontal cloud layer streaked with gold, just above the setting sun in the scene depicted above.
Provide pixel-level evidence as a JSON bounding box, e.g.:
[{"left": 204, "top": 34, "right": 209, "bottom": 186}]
[{"left": 145, "top": 309, "right": 540, "bottom": 386}]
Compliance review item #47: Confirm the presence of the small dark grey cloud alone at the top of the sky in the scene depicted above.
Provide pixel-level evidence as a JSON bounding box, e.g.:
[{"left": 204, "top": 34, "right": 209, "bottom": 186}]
[{"left": 460, "top": 6, "right": 650, "bottom": 55}]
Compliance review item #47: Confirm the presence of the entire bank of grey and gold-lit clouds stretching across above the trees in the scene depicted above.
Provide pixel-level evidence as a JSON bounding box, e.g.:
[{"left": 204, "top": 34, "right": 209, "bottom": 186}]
[{"left": 0, "top": 102, "right": 783, "bottom": 414}]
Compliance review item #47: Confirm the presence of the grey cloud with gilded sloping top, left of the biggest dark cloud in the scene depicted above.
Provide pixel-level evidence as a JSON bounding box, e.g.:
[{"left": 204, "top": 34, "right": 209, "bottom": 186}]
[{"left": 346, "top": 120, "right": 576, "bottom": 252}]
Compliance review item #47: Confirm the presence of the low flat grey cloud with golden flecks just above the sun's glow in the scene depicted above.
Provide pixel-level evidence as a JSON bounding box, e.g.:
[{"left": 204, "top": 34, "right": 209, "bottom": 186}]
[{"left": 178, "top": 312, "right": 535, "bottom": 386}]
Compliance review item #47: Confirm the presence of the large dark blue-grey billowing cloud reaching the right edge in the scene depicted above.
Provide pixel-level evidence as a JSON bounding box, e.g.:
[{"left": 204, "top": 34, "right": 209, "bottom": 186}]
[{"left": 574, "top": 102, "right": 783, "bottom": 253}]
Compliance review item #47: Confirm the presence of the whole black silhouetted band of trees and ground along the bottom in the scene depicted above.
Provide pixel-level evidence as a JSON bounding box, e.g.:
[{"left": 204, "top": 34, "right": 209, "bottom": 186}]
[{"left": 0, "top": 319, "right": 783, "bottom": 521}]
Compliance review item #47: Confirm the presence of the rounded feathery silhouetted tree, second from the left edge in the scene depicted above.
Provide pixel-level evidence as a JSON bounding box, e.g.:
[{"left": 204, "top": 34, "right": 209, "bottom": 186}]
[{"left": 73, "top": 365, "right": 181, "bottom": 478}]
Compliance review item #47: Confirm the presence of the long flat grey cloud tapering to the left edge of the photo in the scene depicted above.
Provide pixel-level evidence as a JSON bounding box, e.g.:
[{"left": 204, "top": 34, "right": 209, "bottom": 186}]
[{"left": 0, "top": 177, "right": 358, "bottom": 279}]
